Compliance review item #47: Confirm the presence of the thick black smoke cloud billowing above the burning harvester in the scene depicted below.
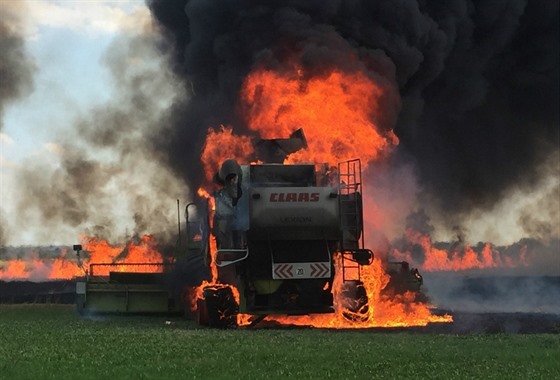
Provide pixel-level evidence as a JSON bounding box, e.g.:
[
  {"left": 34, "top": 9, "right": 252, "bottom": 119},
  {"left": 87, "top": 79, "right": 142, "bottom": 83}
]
[{"left": 148, "top": 0, "right": 560, "bottom": 220}]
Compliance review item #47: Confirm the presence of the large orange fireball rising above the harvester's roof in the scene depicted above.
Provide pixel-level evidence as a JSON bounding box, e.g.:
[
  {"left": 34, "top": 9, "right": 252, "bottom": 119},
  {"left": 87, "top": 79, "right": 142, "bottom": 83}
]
[{"left": 241, "top": 67, "right": 398, "bottom": 164}]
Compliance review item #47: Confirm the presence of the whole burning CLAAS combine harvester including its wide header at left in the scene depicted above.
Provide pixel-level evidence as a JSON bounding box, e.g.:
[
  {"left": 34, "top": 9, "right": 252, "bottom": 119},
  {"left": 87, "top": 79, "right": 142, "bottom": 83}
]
[{"left": 78, "top": 129, "right": 428, "bottom": 328}]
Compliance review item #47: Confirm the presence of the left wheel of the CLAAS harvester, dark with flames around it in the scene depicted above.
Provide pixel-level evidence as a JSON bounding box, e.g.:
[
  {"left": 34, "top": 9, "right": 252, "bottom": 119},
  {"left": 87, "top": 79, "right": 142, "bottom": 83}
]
[{"left": 199, "top": 286, "right": 238, "bottom": 329}]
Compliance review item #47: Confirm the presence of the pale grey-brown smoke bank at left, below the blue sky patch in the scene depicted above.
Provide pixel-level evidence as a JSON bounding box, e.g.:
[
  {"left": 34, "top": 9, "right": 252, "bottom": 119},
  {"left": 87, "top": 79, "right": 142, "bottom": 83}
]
[{"left": 4, "top": 13, "right": 189, "bottom": 244}]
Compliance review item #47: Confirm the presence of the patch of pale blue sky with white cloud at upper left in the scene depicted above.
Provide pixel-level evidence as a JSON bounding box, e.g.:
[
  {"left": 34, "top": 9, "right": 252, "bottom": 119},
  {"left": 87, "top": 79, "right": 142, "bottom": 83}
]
[{"left": 2, "top": 0, "right": 144, "bottom": 158}]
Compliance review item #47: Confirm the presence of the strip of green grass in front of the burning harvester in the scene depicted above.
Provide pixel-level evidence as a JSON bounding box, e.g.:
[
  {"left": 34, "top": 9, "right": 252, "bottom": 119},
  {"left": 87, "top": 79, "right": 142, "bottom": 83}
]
[{"left": 0, "top": 305, "right": 560, "bottom": 380}]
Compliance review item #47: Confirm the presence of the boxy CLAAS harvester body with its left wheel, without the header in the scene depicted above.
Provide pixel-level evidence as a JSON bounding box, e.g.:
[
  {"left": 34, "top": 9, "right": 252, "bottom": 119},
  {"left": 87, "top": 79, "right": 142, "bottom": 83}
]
[{"left": 194, "top": 130, "right": 373, "bottom": 327}]
